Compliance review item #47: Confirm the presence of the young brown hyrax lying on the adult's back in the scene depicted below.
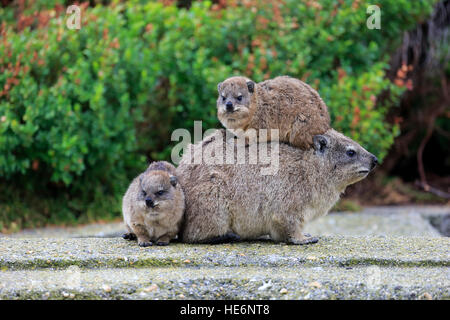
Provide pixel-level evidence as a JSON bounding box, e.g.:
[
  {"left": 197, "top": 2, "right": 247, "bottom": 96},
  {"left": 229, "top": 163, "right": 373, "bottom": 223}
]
[{"left": 217, "top": 76, "right": 330, "bottom": 149}]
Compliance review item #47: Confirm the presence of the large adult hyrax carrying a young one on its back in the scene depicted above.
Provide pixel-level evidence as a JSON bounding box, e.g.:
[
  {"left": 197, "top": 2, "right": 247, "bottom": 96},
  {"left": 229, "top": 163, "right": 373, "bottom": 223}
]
[{"left": 177, "top": 129, "right": 377, "bottom": 244}]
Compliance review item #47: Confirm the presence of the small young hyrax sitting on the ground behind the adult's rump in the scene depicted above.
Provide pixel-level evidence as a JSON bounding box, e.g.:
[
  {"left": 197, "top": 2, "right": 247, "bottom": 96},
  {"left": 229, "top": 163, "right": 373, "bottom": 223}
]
[{"left": 122, "top": 161, "right": 184, "bottom": 247}]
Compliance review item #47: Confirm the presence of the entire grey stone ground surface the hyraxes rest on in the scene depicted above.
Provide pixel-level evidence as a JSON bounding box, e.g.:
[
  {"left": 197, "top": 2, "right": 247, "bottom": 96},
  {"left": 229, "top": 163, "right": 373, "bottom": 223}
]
[{"left": 0, "top": 207, "right": 450, "bottom": 299}]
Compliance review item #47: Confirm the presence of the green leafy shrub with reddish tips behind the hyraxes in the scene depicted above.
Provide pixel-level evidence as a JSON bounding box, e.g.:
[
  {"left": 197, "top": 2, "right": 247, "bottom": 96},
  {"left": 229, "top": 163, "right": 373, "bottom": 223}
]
[{"left": 0, "top": 0, "right": 435, "bottom": 230}]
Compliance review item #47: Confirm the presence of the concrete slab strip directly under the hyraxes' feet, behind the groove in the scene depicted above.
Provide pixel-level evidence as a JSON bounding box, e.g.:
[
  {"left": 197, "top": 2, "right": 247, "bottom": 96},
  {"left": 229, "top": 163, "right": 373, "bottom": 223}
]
[{"left": 0, "top": 236, "right": 450, "bottom": 270}]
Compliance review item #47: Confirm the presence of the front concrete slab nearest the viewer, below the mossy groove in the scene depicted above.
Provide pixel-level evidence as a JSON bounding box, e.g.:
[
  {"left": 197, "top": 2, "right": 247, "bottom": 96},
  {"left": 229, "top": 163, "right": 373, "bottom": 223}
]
[{"left": 0, "top": 265, "right": 450, "bottom": 299}]
